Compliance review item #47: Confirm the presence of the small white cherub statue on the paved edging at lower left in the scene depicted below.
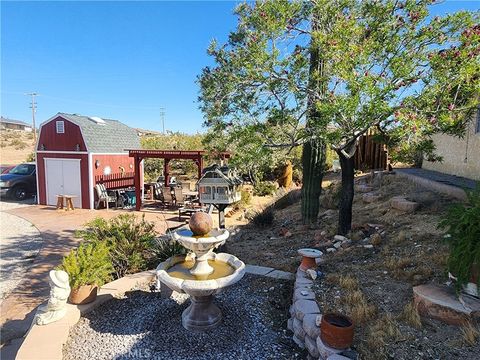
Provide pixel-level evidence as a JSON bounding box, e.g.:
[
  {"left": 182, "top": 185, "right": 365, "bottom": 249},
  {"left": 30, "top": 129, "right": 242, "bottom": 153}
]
[{"left": 35, "top": 270, "right": 70, "bottom": 325}]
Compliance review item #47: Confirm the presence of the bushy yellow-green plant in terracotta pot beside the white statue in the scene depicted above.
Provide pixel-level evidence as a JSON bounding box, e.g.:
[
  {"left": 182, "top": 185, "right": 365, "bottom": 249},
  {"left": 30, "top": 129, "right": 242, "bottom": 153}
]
[{"left": 60, "top": 241, "right": 113, "bottom": 304}]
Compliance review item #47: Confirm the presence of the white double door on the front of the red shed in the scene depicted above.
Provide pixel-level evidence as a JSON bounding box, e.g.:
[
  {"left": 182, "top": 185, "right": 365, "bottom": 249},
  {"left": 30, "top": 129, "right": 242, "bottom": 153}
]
[{"left": 45, "top": 159, "right": 82, "bottom": 207}]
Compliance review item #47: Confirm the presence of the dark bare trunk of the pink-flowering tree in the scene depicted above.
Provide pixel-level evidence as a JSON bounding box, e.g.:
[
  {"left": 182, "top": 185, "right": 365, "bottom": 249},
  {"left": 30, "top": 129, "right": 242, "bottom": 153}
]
[{"left": 337, "top": 151, "right": 355, "bottom": 235}]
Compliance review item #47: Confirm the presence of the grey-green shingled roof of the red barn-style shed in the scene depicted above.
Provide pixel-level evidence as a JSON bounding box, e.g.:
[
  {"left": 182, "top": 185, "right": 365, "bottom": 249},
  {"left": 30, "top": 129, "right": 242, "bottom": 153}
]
[{"left": 57, "top": 113, "right": 140, "bottom": 153}]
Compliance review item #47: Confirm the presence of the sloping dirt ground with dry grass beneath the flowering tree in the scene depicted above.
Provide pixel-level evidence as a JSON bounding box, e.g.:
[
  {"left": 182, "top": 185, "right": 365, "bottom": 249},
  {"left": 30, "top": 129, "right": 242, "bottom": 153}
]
[{"left": 227, "top": 174, "right": 480, "bottom": 359}]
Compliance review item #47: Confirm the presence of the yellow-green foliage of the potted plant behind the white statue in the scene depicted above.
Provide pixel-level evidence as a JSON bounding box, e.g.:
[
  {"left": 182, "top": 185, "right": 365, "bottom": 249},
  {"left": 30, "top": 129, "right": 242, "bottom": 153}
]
[{"left": 59, "top": 242, "right": 113, "bottom": 289}]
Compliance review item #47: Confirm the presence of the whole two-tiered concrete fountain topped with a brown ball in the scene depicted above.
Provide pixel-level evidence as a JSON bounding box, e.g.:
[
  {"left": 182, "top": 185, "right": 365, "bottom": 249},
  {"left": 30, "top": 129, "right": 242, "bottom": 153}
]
[{"left": 157, "top": 213, "right": 245, "bottom": 331}]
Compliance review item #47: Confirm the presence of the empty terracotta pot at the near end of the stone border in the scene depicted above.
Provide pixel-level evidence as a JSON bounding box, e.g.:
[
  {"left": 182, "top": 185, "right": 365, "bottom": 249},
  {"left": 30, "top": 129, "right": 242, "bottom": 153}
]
[{"left": 320, "top": 313, "right": 353, "bottom": 350}]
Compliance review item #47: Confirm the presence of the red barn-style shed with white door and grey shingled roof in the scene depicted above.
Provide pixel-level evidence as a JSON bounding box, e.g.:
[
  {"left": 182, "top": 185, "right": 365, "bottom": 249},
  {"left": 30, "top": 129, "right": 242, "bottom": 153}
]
[{"left": 36, "top": 113, "right": 143, "bottom": 209}]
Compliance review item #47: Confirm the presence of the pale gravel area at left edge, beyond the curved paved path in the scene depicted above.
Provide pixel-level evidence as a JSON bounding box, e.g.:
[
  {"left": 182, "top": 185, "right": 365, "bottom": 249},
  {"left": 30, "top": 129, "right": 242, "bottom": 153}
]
[{"left": 0, "top": 201, "right": 42, "bottom": 304}]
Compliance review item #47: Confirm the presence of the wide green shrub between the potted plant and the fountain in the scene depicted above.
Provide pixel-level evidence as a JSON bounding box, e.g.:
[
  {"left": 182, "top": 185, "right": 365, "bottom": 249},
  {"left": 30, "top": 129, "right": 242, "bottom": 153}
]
[{"left": 77, "top": 214, "right": 155, "bottom": 278}]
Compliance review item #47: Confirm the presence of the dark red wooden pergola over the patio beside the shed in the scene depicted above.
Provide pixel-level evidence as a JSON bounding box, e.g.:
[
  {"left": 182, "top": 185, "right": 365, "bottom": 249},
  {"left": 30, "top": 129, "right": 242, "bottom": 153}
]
[{"left": 128, "top": 149, "right": 230, "bottom": 211}]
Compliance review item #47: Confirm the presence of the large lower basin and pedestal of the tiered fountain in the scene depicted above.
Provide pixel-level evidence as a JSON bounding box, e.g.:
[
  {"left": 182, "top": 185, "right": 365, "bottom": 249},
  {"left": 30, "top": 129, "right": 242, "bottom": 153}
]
[{"left": 157, "top": 252, "right": 245, "bottom": 331}]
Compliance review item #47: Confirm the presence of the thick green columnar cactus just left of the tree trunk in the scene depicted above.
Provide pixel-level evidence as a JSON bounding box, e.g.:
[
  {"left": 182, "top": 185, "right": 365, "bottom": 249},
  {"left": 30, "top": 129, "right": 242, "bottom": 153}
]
[{"left": 302, "top": 139, "right": 325, "bottom": 224}]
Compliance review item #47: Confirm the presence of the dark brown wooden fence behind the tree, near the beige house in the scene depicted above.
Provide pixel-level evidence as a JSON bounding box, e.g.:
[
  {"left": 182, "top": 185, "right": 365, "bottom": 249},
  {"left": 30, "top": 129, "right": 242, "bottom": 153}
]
[{"left": 354, "top": 130, "right": 389, "bottom": 171}]
